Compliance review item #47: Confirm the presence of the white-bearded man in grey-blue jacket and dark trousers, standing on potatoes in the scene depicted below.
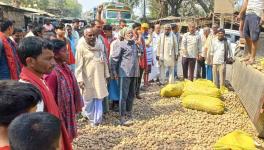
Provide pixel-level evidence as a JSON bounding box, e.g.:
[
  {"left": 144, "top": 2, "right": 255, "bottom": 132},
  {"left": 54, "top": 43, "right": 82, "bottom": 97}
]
[{"left": 111, "top": 27, "right": 139, "bottom": 125}]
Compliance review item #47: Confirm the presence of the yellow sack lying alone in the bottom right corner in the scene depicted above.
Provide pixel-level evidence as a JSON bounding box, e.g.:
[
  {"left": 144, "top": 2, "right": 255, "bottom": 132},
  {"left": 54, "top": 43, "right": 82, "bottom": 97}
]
[{"left": 214, "top": 130, "right": 257, "bottom": 150}]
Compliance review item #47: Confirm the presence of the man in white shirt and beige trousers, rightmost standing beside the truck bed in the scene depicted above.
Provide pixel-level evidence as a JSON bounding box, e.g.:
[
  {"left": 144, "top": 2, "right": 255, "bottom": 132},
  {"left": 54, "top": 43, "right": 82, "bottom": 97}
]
[{"left": 210, "top": 28, "right": 230, "bottom": 87}]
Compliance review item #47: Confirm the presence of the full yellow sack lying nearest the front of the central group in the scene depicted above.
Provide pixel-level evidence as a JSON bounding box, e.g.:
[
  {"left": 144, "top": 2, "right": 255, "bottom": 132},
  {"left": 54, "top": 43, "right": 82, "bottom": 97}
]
[{"left": 182, "top": 95, "right": 225, "bottom": 114}]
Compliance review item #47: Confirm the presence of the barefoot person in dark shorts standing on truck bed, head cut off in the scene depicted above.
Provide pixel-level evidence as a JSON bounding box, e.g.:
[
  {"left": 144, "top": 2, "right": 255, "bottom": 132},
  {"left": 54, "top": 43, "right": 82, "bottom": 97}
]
[{"left": 239, "top": 0, "right": 264, "bottom": 65}]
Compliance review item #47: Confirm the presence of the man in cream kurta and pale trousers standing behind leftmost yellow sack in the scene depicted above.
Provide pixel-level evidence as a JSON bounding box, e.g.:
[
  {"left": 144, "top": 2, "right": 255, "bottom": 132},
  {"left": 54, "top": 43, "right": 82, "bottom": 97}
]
[{"left": 156, "top": 24, "right": 178, "bottom": 84}]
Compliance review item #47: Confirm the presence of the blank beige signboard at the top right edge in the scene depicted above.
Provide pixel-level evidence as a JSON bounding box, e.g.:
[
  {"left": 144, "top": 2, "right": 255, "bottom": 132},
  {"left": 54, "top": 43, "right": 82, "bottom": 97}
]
[{"left": 214, "top": 0, "right": 234, "bottom": 14}]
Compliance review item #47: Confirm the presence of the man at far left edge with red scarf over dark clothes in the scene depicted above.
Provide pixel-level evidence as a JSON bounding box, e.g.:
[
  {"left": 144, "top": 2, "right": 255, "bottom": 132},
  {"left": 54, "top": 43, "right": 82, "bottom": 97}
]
[{"left": 0, "top": 20, "right": 21, "bottom": 80}]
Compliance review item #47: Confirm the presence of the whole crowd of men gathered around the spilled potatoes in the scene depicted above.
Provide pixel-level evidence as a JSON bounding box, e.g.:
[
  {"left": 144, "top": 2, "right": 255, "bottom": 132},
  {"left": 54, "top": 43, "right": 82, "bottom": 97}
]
[{"left": 0, "top": 1, "right": 262, "bottom": 150}]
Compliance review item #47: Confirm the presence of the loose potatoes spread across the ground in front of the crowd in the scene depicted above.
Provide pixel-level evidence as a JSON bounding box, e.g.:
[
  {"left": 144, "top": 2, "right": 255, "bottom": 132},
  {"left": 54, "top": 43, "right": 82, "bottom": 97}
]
[{"left": 74, "top": 85, "right": 263, "bottom": 150}]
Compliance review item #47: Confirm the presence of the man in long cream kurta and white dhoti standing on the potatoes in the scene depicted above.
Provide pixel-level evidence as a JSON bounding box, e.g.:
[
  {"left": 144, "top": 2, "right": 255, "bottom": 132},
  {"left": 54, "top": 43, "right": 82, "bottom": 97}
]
[{"left": 75, "top": 28, "right": 110, "bottom": 126}]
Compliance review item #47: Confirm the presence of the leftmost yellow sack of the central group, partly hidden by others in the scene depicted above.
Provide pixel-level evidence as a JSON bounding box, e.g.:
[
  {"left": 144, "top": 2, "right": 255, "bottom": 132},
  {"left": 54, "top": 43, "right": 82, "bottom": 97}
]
[{"left": 160, "top": 82, "right": 184, "bottom": 97}]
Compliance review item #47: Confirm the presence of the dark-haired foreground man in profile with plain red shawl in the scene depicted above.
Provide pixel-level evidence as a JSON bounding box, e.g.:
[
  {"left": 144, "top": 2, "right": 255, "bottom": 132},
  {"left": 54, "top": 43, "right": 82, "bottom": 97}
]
[{"left": 18, "top": 37, "right": 72, "bottom": 150}]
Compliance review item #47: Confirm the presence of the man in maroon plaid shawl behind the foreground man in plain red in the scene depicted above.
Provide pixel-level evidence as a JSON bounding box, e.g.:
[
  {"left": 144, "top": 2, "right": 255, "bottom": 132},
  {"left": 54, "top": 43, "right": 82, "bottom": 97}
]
[{"left": 45, "top": 39, "right": 83, "bottom": 141}]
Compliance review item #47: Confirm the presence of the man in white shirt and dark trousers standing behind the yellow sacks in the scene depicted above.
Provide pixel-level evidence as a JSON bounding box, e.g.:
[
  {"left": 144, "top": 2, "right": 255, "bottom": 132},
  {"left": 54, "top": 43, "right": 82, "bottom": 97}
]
[{"left": 181, "top": 22, "right": 202, "bottom": 81}]
